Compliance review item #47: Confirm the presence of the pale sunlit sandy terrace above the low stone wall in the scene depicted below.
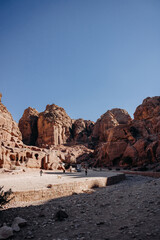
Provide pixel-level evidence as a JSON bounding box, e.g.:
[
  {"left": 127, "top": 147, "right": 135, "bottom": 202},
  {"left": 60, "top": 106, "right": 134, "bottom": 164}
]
[{"left": 0, "top": 170, "right": 121, "bottom": 191}]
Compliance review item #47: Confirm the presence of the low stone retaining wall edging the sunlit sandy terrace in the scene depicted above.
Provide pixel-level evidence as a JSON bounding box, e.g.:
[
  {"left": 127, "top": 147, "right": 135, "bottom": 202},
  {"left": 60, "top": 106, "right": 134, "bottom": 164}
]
[{"left": 12, "top": 174, "right": 125, "bottom": 202}]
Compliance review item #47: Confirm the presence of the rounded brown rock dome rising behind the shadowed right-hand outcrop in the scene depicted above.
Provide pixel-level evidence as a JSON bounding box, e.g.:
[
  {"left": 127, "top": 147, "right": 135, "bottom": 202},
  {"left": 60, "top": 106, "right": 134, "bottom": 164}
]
[{"left": 92, "top": 108, "right": 132, "bottom": 142}]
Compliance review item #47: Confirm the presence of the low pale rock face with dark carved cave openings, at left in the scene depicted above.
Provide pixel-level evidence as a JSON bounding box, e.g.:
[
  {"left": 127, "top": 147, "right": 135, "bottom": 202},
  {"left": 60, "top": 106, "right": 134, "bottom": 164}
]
[{"left": 0, "top": 141, "right": 61, "bottom": 170}]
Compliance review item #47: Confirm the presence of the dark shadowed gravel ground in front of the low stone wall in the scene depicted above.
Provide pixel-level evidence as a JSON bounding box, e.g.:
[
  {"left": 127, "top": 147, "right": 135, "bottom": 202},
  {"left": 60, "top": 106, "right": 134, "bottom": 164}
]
[{"left": 0, "top": 175, "right": 160, "bottom": 240}]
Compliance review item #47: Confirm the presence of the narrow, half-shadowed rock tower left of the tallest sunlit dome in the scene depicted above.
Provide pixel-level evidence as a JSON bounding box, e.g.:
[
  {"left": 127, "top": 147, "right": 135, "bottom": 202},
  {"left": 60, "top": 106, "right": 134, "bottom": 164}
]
[{"left": 18, "top": 107, "right": 39, "bottom": 146}]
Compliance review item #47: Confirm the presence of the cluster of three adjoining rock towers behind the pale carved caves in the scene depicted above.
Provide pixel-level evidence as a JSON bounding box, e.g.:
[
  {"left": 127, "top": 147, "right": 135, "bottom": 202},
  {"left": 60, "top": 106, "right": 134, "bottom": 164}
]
[{"left": 19, "top": 104, "right": 94, "bottom": 147}]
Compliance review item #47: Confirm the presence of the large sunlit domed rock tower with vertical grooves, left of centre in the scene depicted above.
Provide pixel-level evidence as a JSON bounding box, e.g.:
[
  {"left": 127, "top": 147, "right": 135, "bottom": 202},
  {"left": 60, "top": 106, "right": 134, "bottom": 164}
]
[{"left": 37, "top": 104, "right": 72, "bottom": 147}]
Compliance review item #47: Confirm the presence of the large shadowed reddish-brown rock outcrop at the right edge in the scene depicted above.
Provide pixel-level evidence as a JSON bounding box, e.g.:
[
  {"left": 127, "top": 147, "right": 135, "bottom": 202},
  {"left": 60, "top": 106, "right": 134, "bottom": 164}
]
[{"left": 94, "top": 97, "right": 160, "bottom": 167}]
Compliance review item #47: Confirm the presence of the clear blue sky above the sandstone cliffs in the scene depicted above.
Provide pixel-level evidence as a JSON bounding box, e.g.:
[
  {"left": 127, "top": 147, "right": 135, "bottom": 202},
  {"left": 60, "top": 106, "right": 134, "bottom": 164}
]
[{"left": 0, "top": 0, "right": 160, "bottom": 122}]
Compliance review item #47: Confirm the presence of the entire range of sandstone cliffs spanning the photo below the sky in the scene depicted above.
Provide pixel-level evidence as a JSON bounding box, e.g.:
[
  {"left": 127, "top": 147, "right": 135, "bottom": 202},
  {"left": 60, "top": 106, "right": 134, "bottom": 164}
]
[{"left": 0, "top": 95, "right": 160, "bottom": 169}]
